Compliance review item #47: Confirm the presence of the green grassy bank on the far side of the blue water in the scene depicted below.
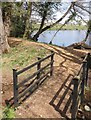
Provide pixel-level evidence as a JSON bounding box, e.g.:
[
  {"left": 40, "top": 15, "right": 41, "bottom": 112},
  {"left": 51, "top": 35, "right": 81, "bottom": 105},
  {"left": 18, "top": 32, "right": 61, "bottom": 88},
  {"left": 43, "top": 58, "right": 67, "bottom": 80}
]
[{"left": 33, "top": 24, "right": 87, "bottom": 30}]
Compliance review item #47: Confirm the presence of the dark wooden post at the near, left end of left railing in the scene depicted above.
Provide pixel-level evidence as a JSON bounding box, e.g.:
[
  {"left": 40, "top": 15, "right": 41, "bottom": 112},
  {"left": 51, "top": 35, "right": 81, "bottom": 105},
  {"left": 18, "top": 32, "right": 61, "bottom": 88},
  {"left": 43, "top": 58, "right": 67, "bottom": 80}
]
[{"left": 13, "top": 69, "right": 18, "bottom": 107}]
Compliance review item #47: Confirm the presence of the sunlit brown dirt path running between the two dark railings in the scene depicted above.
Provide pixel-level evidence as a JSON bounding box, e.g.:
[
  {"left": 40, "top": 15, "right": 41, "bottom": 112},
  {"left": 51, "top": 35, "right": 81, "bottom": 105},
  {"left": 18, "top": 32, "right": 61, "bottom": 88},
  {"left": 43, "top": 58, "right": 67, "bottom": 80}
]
[{"left": 16, "top": 45, "right": 81, "bottom": 118}]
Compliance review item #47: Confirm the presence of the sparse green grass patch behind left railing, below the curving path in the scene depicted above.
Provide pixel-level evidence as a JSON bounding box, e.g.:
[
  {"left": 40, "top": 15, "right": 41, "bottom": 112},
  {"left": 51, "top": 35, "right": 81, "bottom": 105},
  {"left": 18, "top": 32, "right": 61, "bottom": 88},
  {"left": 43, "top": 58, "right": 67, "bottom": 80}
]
[{"left": 2, "top": 43, "right": 48, "bottom": 69}]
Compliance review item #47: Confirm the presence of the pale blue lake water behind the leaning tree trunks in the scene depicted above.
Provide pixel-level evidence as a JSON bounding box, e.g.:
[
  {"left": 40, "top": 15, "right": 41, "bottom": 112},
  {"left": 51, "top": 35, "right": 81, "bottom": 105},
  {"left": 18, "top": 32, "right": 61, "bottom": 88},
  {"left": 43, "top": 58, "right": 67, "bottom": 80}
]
[{"left": 38, "top": 30, "right": 86, "bottom": 47}]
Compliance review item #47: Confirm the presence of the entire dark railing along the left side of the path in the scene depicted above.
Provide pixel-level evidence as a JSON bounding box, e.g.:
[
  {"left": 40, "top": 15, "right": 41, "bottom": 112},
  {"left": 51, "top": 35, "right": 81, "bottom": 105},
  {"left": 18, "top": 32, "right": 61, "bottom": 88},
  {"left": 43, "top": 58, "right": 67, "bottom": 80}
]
[{"left": 13, "top": 51, "right": 54, "bottom": 107}]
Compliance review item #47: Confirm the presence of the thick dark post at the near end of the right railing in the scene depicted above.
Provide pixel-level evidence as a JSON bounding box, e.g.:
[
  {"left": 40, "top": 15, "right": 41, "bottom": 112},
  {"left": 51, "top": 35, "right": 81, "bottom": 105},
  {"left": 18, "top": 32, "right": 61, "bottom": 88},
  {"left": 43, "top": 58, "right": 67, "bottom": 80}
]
[{"left": 71, "top": 76, "right": 79, "bottom": 120}]
